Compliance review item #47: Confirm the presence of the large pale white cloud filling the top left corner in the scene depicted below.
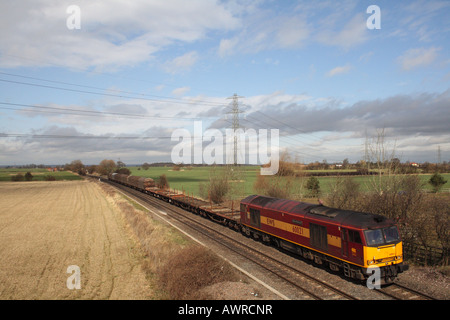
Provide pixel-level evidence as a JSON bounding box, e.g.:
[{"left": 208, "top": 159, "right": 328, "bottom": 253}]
[{"left": 0, "top": 0, "right": 239, "bottom": 70}]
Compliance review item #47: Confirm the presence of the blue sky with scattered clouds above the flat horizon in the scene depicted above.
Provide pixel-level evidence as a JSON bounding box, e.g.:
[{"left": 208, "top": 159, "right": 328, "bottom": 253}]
[{"left": 0, "top": 0, "right": 450, "bottom": 165}]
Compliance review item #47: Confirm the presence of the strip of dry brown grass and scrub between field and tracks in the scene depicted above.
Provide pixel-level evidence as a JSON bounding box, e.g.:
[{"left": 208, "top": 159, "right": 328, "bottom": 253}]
[{"left": 97, "top": 184, "right": 243, "bottom": 300}]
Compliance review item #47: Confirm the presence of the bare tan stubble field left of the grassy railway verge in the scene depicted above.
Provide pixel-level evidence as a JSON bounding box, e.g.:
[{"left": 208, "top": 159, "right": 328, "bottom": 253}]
[{"left": 0, "top": 181, "right": 151, "bottom": 299}]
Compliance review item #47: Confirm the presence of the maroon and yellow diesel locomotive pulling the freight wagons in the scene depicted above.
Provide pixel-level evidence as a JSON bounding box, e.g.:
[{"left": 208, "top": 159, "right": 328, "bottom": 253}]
[{"left": 240, "top": 195, "right": 408, "bottom": 283}]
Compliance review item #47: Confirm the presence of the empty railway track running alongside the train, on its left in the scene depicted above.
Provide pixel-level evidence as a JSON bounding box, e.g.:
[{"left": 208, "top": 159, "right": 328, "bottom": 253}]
[{"left": 105, "top": 180, "right": 358, "bottom": 300}]
